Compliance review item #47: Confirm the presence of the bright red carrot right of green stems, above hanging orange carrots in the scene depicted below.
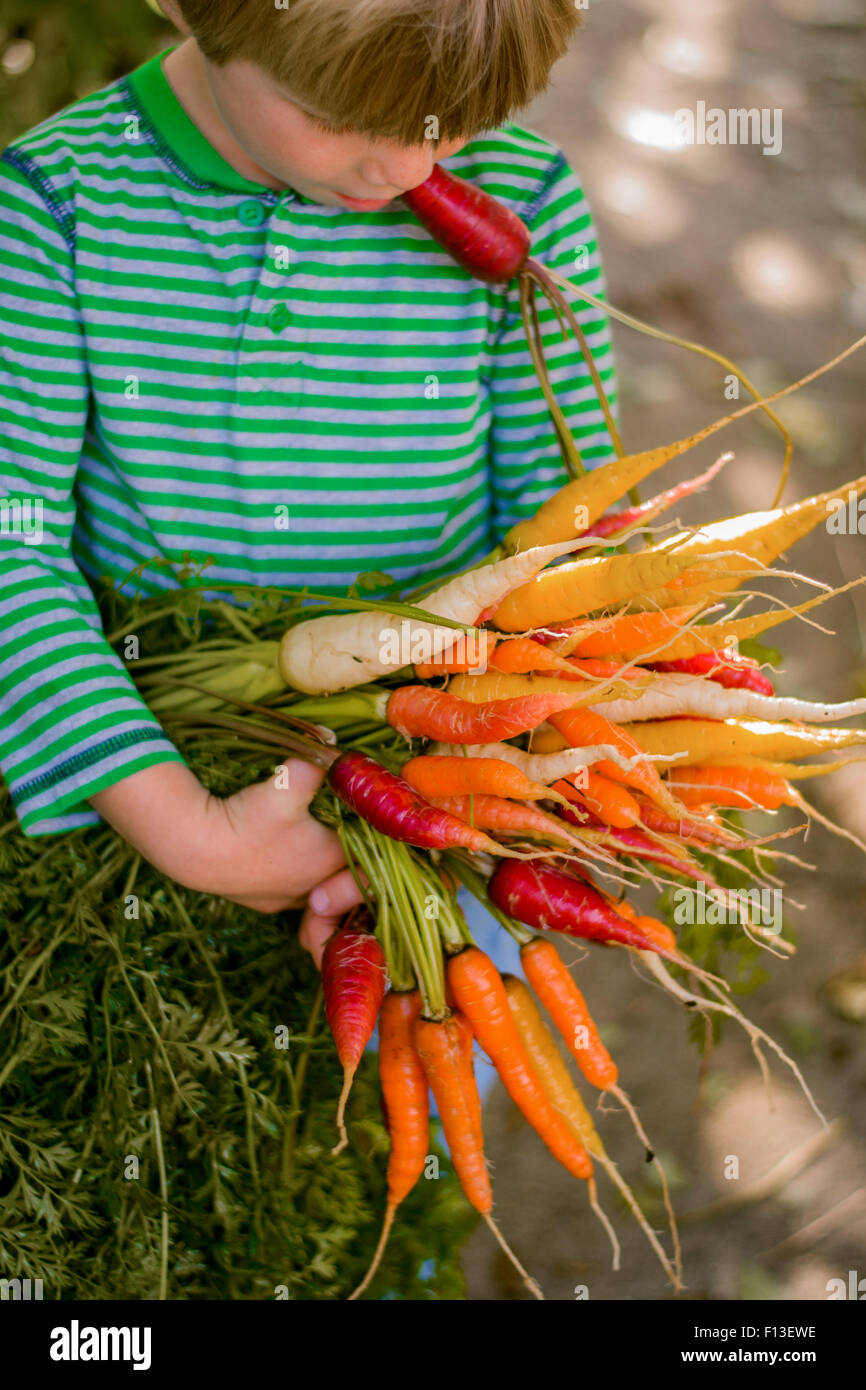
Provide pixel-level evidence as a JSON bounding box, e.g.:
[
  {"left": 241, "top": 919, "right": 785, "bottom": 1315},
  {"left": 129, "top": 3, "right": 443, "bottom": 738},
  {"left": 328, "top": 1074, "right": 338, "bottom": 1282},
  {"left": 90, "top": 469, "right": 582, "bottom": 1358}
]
[{"left": 488, "top": 859, "right": 676, "bottom": 952}]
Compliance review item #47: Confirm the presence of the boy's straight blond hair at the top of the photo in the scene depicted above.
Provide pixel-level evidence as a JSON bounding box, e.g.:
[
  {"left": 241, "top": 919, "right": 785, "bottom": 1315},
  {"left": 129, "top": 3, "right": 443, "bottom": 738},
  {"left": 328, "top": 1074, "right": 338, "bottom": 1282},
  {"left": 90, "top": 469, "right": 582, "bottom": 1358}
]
[{"left": 178, "top": 0, "right": 580, "bottom": 145}]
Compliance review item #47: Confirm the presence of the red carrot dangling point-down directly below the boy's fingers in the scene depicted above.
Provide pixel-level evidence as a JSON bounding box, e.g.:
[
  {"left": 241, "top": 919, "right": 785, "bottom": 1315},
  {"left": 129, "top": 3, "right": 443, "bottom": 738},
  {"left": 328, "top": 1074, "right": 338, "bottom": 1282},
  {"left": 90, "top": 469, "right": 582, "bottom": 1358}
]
[{"left": 321, "top": 913, "right": 386, "bottom": 1154}]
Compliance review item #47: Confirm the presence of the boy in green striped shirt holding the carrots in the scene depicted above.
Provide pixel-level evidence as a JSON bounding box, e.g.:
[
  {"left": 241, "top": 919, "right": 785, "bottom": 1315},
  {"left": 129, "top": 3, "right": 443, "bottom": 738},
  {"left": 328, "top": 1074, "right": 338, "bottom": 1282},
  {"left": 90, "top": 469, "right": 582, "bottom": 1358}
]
[{"left": 0, "top": 0, "right": 613, "bottom": 958}]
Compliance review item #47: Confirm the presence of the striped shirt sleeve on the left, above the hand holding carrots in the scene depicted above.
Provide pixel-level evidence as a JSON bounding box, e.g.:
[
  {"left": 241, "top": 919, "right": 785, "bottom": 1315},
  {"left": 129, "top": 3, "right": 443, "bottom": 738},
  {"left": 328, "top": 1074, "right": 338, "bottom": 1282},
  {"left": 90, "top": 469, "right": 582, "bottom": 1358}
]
[{"left": 0, "top": 162, "right": 182, "bottom": 835}]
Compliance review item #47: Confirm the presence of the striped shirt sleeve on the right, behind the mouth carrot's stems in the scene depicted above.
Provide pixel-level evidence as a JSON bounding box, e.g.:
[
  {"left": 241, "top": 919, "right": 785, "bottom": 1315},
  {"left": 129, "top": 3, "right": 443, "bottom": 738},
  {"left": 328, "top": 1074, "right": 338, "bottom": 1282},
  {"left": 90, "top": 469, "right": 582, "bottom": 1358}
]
[{"left": 489, "top": 152, "right": 619, "bottom": 541}]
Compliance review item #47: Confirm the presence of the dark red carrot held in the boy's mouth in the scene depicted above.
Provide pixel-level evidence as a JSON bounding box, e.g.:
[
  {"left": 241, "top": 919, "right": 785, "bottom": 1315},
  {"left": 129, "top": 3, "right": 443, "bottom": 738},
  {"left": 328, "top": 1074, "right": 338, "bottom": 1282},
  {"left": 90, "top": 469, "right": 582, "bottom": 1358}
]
[{"left": 403, "top": 164, "right": 530, "bottom": 285}]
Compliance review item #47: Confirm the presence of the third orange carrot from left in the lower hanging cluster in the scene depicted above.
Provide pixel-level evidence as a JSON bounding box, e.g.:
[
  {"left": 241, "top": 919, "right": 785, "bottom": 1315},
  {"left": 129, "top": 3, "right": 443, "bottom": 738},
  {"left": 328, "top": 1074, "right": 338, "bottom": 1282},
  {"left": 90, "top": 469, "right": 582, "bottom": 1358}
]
[{"left": 446, "top": 947, "right": 592, "bottom": 1179}]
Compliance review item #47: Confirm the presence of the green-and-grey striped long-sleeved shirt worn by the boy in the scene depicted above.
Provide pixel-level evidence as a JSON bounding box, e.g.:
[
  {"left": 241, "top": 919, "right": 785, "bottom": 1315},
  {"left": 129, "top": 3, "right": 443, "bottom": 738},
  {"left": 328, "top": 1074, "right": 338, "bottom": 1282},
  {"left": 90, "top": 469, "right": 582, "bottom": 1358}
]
[{"left": 0, "top": 50, "right": 614, "bottom": 835}]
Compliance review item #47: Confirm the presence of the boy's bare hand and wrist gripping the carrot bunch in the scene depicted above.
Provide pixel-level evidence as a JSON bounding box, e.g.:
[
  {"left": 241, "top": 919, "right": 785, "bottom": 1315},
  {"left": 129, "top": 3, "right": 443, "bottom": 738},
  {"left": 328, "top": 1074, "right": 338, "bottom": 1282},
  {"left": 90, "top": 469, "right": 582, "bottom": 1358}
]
[{"left": 90, "top": 759, "right": 360, "bottom": 928}]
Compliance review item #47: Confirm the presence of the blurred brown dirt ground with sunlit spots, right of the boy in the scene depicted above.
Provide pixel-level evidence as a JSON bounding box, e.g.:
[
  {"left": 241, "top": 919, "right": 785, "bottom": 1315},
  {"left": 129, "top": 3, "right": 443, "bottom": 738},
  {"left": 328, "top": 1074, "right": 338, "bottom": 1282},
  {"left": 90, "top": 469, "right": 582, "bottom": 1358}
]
[{"left": 466, "top": 0, "right": 866, "bottom": 1300}]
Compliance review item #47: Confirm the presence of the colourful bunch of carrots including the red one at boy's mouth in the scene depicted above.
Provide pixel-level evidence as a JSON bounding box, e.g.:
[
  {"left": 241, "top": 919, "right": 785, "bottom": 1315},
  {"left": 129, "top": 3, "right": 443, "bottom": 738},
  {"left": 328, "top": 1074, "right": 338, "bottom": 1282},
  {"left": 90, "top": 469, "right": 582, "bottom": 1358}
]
[{"left": 140, "top": 170, "right": 866, "bottom": 1297}]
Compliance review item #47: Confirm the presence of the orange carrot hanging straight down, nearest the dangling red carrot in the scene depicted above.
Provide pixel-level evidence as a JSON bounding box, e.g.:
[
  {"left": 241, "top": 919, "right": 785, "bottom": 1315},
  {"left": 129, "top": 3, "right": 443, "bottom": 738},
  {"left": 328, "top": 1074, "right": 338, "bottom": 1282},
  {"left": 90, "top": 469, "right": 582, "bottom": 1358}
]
[{"left": 349, "top": 990, "right": 430, "bottom": 1302}]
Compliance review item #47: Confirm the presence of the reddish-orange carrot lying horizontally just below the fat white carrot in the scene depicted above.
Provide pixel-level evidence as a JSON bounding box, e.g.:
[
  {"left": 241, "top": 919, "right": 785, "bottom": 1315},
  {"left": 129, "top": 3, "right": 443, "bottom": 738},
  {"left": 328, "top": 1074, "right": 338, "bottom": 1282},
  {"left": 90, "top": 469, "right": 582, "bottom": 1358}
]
[{"left": 386, "top": 685, "right": 573, "bottom": 744}]
